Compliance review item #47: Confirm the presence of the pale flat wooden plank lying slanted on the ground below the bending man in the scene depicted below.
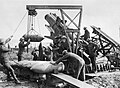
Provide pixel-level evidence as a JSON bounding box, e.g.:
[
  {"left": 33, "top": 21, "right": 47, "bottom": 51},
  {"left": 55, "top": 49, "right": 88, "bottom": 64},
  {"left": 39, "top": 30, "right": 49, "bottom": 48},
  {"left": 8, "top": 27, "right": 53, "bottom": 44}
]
[{"left": 52, "top": 73, "right": 95, "bottom": 88}]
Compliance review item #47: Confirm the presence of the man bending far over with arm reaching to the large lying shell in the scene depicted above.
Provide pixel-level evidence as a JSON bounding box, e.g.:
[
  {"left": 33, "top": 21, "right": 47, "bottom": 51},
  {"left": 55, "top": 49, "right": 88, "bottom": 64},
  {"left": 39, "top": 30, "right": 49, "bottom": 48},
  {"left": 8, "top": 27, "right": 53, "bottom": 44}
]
[{"left": 52, "top": 50, "right": 85, "bottom": 81}]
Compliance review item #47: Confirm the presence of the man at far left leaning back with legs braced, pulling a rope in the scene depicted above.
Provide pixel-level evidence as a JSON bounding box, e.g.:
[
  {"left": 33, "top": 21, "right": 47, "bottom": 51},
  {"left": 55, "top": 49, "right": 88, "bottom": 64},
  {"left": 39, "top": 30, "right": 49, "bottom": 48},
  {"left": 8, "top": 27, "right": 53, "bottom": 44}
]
[{"left": 0, "top": 39, "right": 20, "bottom": 84}]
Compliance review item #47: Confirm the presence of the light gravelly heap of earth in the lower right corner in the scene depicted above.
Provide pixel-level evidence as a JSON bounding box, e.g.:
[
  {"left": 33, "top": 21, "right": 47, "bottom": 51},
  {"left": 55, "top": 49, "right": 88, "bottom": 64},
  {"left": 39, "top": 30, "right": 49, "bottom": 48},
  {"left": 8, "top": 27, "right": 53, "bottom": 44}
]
[{"left": 86, "top": 71, "right": 120, "bottom": 88}]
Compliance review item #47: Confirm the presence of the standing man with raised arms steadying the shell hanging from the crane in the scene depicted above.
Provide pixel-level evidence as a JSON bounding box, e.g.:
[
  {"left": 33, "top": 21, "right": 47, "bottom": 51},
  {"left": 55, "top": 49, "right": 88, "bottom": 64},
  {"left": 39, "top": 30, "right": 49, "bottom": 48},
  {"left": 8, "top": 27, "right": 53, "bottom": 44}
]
[{"left": 18, "top": 37, "right": 30, "bottom": 61}]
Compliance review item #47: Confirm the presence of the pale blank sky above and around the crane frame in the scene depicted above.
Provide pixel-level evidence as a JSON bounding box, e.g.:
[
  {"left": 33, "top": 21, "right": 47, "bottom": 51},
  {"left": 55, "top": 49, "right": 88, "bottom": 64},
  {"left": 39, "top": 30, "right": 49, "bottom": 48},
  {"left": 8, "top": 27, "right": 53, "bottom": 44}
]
[{"left": 0, "top": 0, "right": 120, "bottom": 45}]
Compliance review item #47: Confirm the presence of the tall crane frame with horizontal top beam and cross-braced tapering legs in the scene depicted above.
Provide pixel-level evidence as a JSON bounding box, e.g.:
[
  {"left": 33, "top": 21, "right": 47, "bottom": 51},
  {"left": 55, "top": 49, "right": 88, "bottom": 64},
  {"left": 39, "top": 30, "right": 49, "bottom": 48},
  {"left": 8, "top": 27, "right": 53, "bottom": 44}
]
[{"left": 26, "top": 5, "right": 82, "bottom": 53}]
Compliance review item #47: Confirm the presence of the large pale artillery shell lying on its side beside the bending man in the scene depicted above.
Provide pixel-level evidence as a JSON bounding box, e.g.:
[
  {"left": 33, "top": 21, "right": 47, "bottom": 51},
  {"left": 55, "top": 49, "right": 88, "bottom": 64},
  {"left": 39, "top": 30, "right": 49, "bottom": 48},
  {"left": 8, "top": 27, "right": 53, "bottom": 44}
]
[{"left": 30, "top": 62, "right": 64, "bottom": 73}]
